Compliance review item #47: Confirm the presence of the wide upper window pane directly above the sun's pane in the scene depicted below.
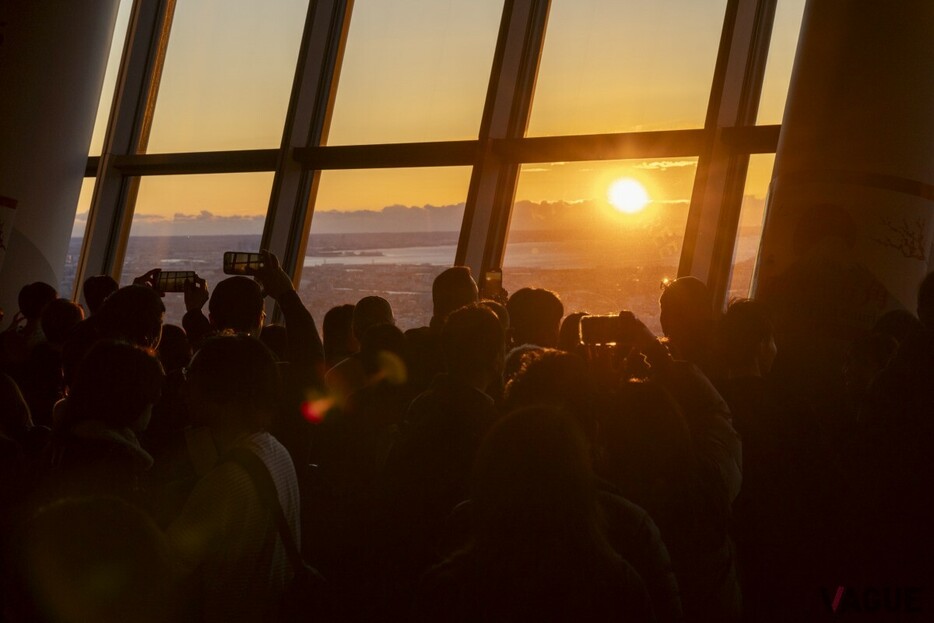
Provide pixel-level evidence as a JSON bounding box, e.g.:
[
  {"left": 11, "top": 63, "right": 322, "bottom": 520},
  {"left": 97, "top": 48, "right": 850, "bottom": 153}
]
[{"left": 528, "top": 0, "right": 726, "bottom": 136}]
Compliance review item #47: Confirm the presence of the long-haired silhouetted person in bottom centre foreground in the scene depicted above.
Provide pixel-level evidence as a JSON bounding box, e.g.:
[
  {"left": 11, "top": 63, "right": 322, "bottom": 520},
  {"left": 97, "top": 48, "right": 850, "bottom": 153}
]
[{"left": 416, "top": 408, "right": 654, "bottom": 621}]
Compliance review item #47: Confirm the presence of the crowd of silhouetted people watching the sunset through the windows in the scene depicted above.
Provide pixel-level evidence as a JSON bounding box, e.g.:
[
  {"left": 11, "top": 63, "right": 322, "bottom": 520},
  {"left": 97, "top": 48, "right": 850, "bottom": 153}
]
[{"left": 0, "top": 254, "right": 934, "bottom": 623}]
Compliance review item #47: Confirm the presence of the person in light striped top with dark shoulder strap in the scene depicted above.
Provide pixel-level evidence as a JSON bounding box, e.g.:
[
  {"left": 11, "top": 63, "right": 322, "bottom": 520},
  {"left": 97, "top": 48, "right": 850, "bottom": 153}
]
[{"left": 168, "top": 335, "right": 301, "bottom": 621}]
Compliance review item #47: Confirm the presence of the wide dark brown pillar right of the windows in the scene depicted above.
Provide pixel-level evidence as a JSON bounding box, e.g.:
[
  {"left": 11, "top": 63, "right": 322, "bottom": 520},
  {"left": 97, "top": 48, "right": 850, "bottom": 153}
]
[{"left": 756, "top": 0, "right": 934, "bottom": 394}]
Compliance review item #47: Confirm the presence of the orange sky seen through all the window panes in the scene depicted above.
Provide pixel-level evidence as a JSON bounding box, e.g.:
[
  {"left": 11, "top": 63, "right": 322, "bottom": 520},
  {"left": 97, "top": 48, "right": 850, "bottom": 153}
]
[{"left": 78, "top": 0, "right": 804, "bottom": 235}]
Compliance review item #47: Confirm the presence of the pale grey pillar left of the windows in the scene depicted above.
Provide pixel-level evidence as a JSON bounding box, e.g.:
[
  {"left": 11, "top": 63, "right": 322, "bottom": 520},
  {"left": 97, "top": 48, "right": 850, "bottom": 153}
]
[{"left": 0, "top": 0, "right": 120, "bottom": 322}]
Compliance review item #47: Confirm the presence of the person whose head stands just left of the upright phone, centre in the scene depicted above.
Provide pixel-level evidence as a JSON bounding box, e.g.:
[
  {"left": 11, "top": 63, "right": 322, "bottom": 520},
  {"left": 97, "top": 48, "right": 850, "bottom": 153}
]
[{"left": 405, "top": 266, "right": 478, "bottom": 391}]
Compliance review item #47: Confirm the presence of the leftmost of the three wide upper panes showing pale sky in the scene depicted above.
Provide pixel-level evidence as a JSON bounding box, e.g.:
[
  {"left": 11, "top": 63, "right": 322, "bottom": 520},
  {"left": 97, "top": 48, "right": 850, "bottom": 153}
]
[{"left": 148, "top": 0, "right": 308, "bottom": 153}]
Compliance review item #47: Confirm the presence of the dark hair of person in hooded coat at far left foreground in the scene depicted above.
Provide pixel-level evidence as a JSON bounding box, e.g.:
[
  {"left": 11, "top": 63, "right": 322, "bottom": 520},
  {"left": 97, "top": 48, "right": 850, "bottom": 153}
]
[{"left": 64, "top": 340, "right": 164, "bottom": 429}]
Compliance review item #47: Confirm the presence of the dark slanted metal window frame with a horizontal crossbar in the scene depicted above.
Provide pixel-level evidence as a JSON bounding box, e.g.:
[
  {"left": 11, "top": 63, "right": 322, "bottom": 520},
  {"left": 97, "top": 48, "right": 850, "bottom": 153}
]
[{"left": 75, "top": 0, "right": 780, "bottom": 314}]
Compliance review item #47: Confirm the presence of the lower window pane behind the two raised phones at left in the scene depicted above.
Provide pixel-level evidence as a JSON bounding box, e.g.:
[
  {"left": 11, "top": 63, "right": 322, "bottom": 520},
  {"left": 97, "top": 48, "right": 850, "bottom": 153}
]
[{"left": 120, "top": 173, "right": 273, "bottom": 324}]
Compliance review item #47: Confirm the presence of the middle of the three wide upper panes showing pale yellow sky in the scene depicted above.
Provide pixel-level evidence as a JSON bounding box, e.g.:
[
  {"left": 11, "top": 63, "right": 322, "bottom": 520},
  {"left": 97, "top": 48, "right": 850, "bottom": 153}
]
[{"left": 328, "top": 0, "right": 503, "bottom": 145}]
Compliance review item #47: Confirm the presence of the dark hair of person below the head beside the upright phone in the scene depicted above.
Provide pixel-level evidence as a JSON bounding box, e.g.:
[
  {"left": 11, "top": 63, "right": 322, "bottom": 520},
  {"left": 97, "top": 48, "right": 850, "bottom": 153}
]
[{"left": 441, "top": 304, "right": 505, "bottom": 376}]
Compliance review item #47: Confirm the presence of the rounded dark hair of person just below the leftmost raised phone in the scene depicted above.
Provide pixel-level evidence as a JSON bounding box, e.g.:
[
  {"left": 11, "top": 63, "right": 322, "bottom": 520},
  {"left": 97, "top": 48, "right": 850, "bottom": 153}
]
[{"left": 100, "top": 285, "right": 165, "bottom": 348}]
